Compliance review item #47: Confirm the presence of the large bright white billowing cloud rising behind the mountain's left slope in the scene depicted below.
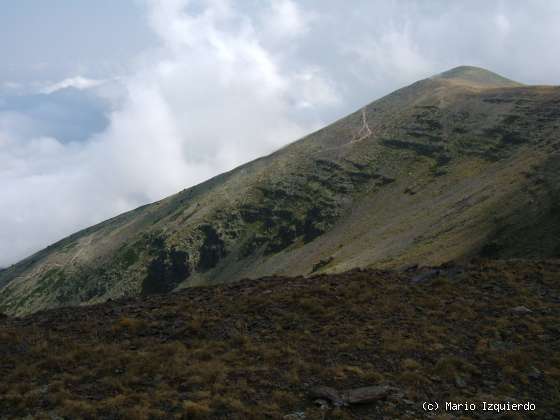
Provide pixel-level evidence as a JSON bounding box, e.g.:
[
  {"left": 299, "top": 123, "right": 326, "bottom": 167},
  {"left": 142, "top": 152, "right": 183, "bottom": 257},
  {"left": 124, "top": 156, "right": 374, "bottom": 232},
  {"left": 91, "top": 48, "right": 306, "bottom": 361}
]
[{"left": 0, "top": 0, "right": 337, "bottom": 265}]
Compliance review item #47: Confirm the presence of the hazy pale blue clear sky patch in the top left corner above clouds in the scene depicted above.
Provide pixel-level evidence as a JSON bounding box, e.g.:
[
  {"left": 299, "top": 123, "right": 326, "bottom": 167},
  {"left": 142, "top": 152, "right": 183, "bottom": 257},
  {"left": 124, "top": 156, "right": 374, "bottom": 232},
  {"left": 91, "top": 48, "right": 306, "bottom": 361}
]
[{"left": 0, "top": 0, "right": 157, "bottom": 83}]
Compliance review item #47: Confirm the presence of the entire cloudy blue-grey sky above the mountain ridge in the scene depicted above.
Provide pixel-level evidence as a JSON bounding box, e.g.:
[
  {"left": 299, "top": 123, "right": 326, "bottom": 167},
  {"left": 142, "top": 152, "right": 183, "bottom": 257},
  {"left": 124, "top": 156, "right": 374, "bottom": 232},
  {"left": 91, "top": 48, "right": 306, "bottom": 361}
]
[{"left": 0, "top": 0, "right": 560, "bottom": 266}]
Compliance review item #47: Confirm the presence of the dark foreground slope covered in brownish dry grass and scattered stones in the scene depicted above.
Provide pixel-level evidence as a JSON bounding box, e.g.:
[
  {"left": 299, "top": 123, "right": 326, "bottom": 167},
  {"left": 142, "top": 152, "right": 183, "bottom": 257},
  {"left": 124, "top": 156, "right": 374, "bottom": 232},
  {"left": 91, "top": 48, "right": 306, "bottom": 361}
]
[{"left": 0, "top": 260, "right": 560, "bottom": 420}]
